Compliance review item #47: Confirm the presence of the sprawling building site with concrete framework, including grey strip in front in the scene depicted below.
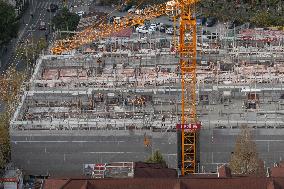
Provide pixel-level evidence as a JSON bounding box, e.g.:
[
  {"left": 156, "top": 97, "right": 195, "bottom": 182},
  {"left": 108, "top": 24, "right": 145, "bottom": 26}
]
[{"left": 7, "top": 0, "right": 284, "bottom": 176}]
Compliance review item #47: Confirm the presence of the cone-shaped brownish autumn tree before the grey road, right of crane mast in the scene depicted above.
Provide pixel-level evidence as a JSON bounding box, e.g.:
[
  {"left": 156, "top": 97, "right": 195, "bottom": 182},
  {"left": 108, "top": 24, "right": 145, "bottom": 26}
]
[{"left": 229, "top": 126, "right": 265, "bottom": 176}]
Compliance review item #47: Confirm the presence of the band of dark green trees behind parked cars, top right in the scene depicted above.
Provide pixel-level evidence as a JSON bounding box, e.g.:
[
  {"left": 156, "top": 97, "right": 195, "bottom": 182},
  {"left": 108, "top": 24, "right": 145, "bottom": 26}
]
[{"left": 197, "top": 0, "right": 284, "bottom": 27}]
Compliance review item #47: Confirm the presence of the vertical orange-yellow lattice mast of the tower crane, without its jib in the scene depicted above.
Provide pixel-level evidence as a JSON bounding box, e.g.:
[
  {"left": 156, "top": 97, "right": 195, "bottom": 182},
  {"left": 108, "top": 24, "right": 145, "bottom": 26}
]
[{"left": 179, "top": 0, "right": 200, "bottom": 175}]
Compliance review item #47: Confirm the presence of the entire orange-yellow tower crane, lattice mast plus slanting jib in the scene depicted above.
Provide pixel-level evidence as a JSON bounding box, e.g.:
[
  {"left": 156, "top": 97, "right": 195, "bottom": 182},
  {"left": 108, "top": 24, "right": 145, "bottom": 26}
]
[{"left": 51, "top": 0, "right": 201, "bottom": 175}]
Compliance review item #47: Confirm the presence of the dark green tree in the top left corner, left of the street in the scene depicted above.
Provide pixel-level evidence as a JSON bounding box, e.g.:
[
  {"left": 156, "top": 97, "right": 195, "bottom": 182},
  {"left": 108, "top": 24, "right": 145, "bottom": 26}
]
[{"left": 0, "top": 0, "right": 19, "bottom": 44}]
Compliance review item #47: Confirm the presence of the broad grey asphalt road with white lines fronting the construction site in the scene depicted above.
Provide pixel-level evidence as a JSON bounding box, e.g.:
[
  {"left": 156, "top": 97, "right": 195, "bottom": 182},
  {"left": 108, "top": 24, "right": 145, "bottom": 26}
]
[{"left": 11, "top": 129, "right": 284, "bottom": 176}]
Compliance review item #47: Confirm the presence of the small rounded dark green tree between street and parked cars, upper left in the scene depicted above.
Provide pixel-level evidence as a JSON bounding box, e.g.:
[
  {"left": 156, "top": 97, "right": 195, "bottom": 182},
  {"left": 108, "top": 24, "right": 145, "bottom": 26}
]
[{"left": 52, "top": 7, "right": 80, "bottom": 31}]
